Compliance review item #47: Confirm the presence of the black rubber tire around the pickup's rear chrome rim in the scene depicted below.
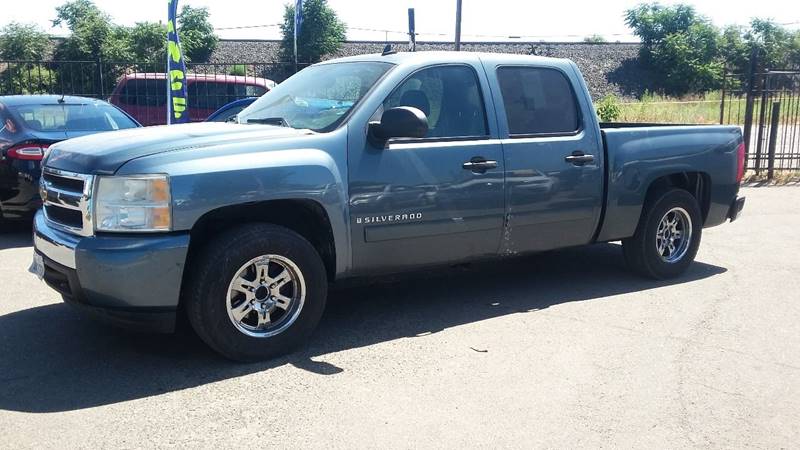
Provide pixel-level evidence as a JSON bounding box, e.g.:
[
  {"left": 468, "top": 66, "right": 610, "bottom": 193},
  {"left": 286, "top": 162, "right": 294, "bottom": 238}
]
[{"left": 622, "top": 188, "right": 703, "bottom": 280}]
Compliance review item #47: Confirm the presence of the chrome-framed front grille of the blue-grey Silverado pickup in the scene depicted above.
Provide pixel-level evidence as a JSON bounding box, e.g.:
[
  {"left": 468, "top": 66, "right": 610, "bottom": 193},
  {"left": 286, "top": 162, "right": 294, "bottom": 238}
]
[{"left": 41, "top": 167, "right": 94, "bottom": 236}]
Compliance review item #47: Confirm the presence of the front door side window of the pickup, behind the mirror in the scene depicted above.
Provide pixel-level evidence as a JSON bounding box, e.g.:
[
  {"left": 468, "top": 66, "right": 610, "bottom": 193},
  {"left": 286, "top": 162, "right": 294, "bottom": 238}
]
[{"left": 383, "top": 65, "right": 489, "bottom": 138}]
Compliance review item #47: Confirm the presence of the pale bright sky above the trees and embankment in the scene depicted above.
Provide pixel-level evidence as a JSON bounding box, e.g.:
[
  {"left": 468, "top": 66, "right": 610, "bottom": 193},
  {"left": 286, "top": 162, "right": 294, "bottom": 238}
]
[{"left": 0, "top": 0, "right": 800, "bottom": 42}]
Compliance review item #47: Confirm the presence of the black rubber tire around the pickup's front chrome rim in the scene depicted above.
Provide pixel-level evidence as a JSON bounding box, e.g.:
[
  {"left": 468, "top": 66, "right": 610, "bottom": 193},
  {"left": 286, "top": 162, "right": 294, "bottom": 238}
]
[{"left": 183, "top": 224, "right": 328, "bottom": 362}]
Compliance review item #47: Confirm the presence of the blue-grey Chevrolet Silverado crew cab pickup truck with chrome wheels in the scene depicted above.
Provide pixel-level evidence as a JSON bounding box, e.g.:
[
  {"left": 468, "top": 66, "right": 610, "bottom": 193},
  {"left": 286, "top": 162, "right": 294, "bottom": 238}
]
[{"left": 31, "top": 52, "right": 744, "bottom": 360}]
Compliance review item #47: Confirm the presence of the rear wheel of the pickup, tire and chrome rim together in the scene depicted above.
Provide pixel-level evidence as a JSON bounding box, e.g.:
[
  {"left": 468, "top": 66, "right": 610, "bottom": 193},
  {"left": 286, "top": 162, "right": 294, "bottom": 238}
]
[{"left": 622, "top": 189, "right": 703, "bottom": 279}]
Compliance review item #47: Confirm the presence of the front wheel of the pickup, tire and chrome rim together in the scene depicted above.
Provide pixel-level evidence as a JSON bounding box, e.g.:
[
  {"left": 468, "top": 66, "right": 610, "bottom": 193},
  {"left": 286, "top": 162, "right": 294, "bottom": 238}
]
[{"left": 184, "top": 224, "right": 327, "bottom": 361}]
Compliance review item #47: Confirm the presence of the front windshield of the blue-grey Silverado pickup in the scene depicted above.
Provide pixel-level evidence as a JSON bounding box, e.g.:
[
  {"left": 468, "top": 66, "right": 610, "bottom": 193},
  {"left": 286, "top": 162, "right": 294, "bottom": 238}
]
[{"left": 237, "top": 62, "right": 393, "bottom": 132}]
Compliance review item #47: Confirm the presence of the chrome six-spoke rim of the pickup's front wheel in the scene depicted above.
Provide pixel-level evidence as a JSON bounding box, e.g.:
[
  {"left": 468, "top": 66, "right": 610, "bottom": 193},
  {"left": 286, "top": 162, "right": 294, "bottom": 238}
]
[{"left": 227, "top": 255, "right": 306, "bottom": 338}]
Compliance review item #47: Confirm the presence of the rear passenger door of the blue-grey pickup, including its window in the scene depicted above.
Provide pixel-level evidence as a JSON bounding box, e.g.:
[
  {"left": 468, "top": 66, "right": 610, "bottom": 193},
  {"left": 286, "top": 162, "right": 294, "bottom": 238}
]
[{"left": 488, "top": 65, "right": 603, "bottom": 253}]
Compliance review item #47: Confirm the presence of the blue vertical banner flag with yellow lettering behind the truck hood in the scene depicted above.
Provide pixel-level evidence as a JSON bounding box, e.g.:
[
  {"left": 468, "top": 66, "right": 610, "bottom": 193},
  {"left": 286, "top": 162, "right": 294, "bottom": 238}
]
[{"left": 167, "top": 0, "right": 189, "bottom": 125}]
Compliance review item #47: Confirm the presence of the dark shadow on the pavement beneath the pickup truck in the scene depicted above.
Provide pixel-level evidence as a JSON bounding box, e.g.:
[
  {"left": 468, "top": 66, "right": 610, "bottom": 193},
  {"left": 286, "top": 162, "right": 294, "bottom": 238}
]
[{"left": 0, "top": 244, "right": 726, "bottom": 413}]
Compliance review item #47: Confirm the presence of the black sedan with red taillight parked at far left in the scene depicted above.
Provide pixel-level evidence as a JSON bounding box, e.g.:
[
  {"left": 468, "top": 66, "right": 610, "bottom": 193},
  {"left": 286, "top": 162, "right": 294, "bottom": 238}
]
[{"left": 0, "top": 95, "right": 139, "bottom": 225}]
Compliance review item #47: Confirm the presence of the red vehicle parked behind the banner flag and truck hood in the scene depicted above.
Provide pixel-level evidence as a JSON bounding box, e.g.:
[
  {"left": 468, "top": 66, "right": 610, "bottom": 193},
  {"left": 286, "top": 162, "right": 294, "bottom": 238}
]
[{"left": 109, "top": 73, "right": 275, "bottom": 126}]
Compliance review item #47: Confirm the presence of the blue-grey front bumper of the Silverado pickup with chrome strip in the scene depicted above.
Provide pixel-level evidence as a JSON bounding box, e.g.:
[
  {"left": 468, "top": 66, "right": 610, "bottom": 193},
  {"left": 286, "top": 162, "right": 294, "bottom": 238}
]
[{"left": 33, "top": 211, "right": 189, "bottom": 332}]
